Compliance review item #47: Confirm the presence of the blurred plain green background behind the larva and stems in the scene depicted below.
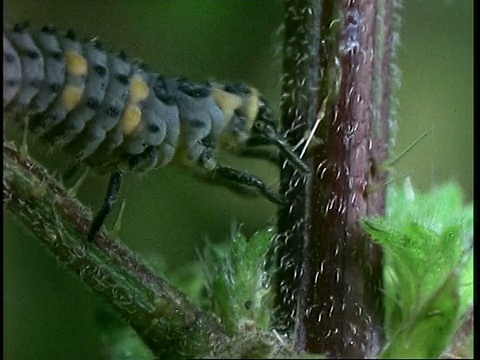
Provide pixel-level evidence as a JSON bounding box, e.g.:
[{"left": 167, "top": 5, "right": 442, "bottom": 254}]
[{"left": 4, "top": 0, "right": 473, "bottom": 360}]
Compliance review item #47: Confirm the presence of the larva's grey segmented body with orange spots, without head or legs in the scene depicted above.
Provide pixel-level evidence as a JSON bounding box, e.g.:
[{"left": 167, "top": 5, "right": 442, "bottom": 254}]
[{"left": 3, "top": 25, "right": 229, "bottom": 171}]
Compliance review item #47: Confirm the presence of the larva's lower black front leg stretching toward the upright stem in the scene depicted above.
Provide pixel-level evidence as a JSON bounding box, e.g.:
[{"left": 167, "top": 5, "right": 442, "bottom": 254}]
[{"left": 213, "top": 164, "right": 285, "bottom": 205}]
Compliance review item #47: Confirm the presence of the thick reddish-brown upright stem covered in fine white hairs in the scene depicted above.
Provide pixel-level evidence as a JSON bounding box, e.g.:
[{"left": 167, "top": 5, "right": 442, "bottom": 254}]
[{"left": 277, "top": 0, "right": 399, "bottom": 357}]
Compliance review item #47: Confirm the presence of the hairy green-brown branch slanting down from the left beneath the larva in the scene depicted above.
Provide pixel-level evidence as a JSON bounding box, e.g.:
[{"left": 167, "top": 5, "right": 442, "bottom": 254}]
[{"left": 3, "top": 142, "right": 228, "bottom": 359}]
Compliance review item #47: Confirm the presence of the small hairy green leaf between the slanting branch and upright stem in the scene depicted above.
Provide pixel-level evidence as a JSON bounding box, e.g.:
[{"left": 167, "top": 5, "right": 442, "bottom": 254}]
[{"left": 204, "top": 229, "right": 275, "bottom": 334}]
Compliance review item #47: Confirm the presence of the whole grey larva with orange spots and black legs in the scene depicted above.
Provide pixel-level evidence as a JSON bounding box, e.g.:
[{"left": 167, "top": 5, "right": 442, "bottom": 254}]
[{"left": 3, "top": 24, "right": 308, "bottom": 241}]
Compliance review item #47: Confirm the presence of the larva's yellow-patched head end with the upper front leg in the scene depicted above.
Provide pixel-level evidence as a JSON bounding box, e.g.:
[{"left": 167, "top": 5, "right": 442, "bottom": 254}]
[{"left": 213, "top": 83, "right": 310, "bottom": 172}]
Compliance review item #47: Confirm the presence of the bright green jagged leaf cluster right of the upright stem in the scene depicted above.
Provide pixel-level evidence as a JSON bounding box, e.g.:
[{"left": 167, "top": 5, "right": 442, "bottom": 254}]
[{"left": 363, "top": 183, "right": 473, "bottom": 357}]
